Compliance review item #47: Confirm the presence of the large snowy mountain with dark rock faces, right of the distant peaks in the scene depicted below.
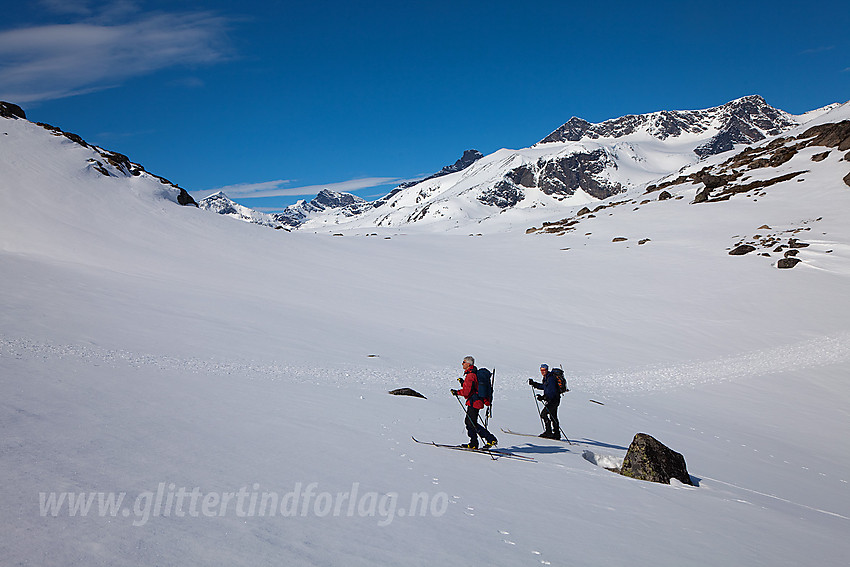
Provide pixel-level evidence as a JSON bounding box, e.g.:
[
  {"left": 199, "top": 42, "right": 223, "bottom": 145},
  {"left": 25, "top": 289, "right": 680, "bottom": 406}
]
[{"left": 305, "top": 95, "right": 835, "bottom": 231}]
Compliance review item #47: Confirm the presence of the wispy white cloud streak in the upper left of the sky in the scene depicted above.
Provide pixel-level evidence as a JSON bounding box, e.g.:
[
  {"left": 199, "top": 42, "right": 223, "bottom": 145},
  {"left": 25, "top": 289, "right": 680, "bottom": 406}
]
[{"left": 0, "top": 6, "right": 230, "bottom": 103}]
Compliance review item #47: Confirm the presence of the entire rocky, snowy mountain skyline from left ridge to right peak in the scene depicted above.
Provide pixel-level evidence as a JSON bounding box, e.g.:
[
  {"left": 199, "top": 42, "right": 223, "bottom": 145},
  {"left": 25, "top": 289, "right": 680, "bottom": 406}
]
[{"left": 0, "top": 95, "right": 841, "bottom": 235}]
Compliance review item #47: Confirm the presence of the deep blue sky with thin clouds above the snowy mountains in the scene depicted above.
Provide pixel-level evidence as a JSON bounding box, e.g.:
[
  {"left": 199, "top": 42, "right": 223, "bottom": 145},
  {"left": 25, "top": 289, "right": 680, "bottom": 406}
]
[{"left": 0, "top": 0, "right": 850, "bottom": 210}]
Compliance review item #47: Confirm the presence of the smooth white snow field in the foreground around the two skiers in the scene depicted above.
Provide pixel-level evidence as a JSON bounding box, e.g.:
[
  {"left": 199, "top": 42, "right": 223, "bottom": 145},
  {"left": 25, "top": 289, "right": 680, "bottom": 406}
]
[{"left": 0, "top": 107, "right": 850, "bottom": 566}]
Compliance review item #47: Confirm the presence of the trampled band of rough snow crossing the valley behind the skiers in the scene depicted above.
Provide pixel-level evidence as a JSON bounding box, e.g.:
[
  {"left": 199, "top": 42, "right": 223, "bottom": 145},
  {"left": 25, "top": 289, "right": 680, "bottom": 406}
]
[{"left": 0, "top": 332, "right": 850, "bottom": 394}]
